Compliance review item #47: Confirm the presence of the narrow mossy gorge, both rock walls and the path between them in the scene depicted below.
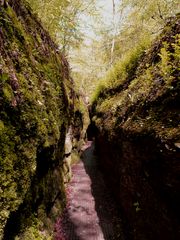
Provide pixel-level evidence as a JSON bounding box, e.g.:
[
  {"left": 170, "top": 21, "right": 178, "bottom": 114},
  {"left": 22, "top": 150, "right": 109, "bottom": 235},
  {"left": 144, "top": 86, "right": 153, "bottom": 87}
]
[{"left": 0, "top": 0, "right": 180, "bottom": 240}]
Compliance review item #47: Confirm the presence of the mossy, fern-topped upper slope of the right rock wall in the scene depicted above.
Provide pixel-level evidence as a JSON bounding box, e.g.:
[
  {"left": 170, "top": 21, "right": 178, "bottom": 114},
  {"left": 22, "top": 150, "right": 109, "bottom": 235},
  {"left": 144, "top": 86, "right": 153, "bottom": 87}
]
[{"left": 93, "top": 15, "right": 180, "bottom": 144}]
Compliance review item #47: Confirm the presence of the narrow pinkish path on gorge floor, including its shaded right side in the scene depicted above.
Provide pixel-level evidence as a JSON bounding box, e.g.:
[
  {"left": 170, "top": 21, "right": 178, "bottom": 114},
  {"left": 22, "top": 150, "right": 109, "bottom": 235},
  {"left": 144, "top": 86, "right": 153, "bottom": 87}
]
[{"left": 56, "top": 142, "right": 124, "bottom": 240}]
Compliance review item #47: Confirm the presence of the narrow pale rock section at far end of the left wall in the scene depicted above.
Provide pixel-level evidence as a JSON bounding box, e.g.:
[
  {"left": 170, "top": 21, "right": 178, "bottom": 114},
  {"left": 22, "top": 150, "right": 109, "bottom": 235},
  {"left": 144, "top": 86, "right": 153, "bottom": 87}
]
[{"left": 63, "top": 90, "right": 90, "bottom": 183}]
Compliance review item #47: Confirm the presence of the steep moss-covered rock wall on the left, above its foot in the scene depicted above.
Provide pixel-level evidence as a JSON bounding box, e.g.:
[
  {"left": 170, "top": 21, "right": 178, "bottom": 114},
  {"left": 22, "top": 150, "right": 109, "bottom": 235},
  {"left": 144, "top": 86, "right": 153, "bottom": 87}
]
[{"left": 0, "top": 0, "right": 69, "bottom": 239}]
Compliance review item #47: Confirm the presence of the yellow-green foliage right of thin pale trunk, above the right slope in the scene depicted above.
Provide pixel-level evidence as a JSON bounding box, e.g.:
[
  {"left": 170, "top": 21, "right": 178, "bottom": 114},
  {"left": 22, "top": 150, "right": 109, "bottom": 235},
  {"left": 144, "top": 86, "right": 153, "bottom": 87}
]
[{"left": 108, "top": 0, "right": 179, "bottom": 62}]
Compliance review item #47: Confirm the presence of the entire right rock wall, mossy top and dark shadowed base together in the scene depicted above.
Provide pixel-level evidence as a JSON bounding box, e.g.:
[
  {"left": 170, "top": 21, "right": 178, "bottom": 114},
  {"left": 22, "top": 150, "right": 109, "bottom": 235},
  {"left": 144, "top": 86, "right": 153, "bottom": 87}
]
[{"left": 93, "top": 16, "right": 180, "bottom": 240}]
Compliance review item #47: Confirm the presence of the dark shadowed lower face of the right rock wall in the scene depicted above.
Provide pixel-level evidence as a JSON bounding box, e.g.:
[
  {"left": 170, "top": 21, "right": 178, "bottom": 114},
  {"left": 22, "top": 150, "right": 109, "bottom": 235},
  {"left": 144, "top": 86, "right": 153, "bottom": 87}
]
[{"left": 97, "top": 135, "right": 180, "bottom": 240}]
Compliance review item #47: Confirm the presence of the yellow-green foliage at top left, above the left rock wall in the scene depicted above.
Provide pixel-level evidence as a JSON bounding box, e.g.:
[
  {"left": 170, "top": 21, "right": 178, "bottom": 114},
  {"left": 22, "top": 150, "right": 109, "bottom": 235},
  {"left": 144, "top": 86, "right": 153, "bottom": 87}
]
[{"left": 27, "top": 0, "right": 95, "bottom": 53}]
